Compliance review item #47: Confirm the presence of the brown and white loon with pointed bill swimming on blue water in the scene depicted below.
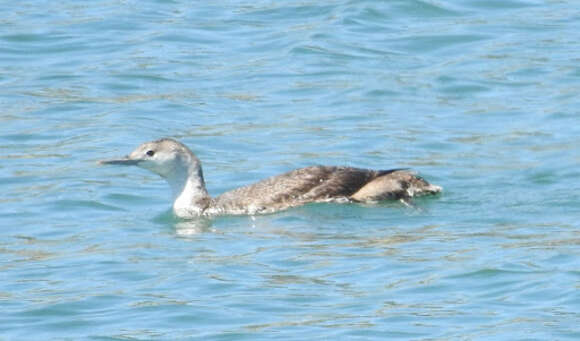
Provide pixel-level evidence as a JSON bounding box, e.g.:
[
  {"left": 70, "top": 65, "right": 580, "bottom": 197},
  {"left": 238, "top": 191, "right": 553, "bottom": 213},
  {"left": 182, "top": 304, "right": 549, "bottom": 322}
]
[{"left": 99, "top": 138, "right": 441, "bottom": 219}]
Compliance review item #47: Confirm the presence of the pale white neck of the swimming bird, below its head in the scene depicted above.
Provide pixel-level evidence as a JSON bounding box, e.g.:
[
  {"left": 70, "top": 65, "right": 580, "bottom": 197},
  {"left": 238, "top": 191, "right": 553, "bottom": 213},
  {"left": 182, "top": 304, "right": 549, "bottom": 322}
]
[{"left": 167, "top": 160, "right": 211, "bottom": 217}]
